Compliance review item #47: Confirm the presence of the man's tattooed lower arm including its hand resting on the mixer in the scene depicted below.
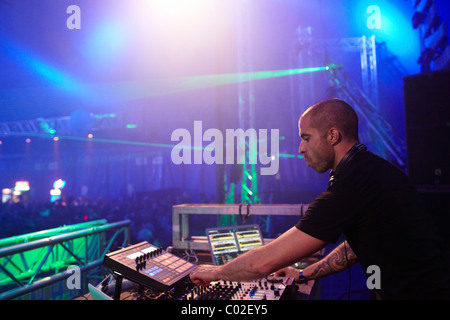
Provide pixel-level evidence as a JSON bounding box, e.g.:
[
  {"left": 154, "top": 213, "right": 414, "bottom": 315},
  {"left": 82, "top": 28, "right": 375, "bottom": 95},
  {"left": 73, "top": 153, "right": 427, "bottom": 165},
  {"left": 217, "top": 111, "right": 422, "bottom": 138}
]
[{"left": 276, "top": 241, "right": 358, "bottom": 281}]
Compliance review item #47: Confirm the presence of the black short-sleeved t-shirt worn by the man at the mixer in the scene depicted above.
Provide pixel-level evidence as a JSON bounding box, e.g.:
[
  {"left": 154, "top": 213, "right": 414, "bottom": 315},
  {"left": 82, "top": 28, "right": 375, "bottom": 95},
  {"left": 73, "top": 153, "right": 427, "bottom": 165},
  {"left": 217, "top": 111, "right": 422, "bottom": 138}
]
[{"left": 296, "top": 151, "right": 450, "bottom": 299}]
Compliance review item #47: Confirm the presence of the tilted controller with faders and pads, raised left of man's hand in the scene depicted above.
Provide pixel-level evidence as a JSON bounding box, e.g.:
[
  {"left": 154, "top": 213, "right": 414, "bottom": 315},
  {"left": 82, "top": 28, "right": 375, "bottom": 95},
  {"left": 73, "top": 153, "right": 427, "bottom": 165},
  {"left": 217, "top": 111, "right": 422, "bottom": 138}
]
[{"left": 103, "top": 241, "right": 197, "bottom": 291}]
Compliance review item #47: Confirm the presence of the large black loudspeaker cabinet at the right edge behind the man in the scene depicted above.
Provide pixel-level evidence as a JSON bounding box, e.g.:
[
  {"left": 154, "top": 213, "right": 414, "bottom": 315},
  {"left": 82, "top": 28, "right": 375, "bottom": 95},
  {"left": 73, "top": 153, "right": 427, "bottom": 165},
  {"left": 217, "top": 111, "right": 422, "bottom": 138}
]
[{"left": 403, "top": 70, "right": 450, "bottom": 185}]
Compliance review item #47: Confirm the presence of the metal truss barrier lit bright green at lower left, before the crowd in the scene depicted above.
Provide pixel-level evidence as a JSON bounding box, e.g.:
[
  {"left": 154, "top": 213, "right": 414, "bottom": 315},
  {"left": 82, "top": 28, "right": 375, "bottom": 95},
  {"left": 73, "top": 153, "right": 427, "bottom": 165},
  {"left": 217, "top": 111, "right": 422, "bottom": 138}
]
[{"left": 0, "top": 220, "right": 130, "bottom": 300}]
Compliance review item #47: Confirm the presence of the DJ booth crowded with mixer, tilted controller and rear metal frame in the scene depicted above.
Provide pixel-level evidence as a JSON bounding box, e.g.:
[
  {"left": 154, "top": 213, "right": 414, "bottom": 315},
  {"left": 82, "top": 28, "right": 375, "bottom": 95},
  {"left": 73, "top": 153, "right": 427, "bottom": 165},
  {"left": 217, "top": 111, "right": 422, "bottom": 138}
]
[{"left": 82, "top": 204, "right": 323, "bottom": 301}]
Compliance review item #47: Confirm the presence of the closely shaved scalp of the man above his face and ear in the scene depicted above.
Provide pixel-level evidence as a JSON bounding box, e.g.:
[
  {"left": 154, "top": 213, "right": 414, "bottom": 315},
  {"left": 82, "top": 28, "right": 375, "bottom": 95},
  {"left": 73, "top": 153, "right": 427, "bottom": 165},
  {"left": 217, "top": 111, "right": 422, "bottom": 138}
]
[{"left": 302, "top": 98, "right": 359, "bottom": 141}]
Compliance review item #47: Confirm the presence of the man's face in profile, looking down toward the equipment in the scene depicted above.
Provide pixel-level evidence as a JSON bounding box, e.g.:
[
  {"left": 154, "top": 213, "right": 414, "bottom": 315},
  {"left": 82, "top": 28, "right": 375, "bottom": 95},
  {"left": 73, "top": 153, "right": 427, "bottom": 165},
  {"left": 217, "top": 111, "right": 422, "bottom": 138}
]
[{"left": 298, "top": 114, "right": 334, "bottom": 173}]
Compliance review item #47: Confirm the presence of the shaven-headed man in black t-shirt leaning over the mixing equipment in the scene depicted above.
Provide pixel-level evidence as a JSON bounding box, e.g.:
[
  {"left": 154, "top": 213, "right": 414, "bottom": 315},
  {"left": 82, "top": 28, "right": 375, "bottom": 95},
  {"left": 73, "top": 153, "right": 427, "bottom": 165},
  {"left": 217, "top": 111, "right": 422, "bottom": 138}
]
[{"left": 190, "top": 99, "right": 450, "bottom": 299}]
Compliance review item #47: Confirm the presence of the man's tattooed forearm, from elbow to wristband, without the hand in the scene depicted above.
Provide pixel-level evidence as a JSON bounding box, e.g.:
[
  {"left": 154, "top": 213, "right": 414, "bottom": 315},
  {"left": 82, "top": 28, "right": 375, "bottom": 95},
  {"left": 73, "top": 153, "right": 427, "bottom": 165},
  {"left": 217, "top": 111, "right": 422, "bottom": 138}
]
[{"left": 307, "top": 241, "right": 358, "bottom": 279}]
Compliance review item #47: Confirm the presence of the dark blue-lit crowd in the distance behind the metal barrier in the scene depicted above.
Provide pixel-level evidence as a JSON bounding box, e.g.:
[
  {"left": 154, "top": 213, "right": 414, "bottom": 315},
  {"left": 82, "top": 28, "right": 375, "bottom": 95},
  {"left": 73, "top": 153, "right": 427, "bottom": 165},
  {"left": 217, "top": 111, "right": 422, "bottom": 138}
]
[{"left": 0, "top": 190, "right": 192, "bottom": 247}]
